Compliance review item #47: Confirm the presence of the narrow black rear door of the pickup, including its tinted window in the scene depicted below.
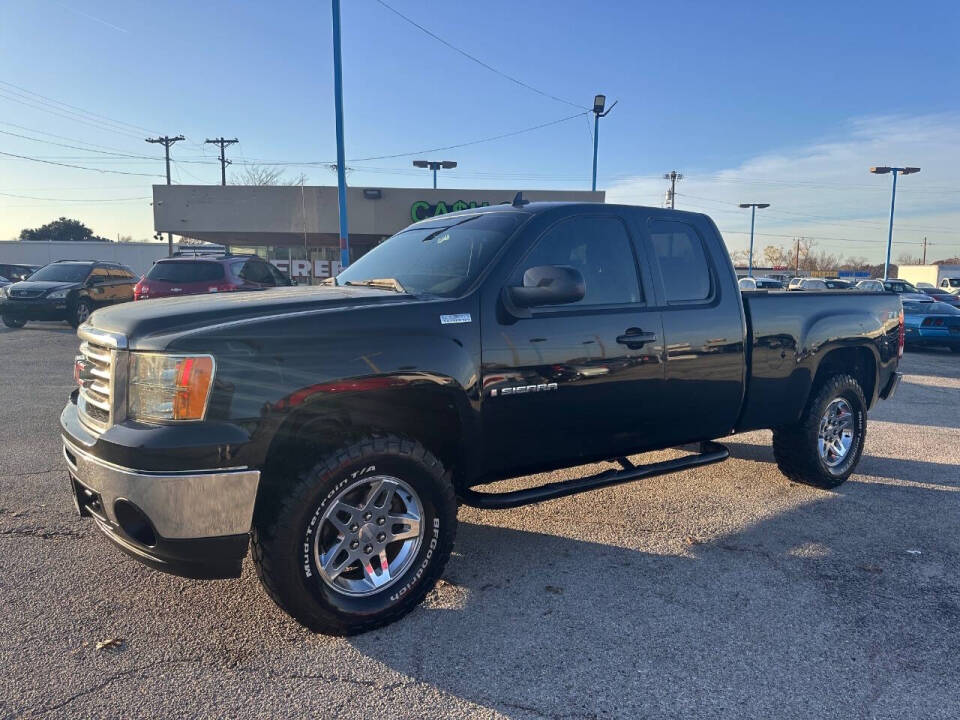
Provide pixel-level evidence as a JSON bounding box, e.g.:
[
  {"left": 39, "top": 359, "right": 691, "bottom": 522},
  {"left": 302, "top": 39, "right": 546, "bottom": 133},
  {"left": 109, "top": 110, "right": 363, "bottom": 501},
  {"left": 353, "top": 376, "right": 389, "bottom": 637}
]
[{"left": 643, "top": 213, "right": 746, "bottom": 443}]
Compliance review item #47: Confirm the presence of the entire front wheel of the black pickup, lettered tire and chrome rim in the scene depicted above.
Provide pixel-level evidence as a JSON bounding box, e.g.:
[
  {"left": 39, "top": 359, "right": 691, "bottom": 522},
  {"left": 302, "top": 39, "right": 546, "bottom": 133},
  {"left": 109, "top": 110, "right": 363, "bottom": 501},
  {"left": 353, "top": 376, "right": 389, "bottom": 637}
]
[{"left": 253, "top": 436, "right": 457, "bottom": 635}]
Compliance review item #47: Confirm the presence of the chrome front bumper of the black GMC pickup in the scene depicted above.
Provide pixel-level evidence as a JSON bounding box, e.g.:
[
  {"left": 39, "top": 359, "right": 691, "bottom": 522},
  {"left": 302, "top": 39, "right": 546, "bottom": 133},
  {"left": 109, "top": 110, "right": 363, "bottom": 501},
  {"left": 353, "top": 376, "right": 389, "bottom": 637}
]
[{"left": 62, "top": 437, "right": 260, "bottom": 540}]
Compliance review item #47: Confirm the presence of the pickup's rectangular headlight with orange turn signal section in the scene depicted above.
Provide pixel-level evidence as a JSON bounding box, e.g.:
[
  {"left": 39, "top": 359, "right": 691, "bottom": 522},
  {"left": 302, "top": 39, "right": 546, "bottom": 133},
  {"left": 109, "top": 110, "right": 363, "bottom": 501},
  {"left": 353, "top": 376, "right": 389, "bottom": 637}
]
[{"left": 127, "top": 352, "right": 214, "bottom": 420}]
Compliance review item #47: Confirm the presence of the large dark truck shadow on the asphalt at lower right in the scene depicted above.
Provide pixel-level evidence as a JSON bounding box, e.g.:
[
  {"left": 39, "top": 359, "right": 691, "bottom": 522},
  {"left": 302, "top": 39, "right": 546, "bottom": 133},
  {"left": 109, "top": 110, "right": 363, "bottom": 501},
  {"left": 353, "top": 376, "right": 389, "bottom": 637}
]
[{"left": 351, "top": 476, "right": 960, "bottom": 717}]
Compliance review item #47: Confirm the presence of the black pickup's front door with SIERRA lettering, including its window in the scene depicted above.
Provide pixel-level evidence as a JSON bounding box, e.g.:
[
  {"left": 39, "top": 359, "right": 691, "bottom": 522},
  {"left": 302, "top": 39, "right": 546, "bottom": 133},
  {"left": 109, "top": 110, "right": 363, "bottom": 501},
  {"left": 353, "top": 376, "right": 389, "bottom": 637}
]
[{"left": 481, "top": 209, "right": 663, "bottom": 475}]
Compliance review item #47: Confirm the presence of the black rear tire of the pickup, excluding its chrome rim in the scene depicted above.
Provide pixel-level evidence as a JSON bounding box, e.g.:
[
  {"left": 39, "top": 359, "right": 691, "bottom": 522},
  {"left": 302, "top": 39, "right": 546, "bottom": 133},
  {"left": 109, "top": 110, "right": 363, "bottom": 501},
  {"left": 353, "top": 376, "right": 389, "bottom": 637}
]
[{"left": 773, "top": 375, "right": 867, "bottom": 489}]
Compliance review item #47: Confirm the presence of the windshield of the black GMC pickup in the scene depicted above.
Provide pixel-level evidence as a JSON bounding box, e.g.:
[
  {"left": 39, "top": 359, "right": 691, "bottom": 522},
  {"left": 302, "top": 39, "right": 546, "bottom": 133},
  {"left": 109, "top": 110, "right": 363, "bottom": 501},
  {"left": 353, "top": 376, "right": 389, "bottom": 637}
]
[{"left": 336, "top": 212, "right": 529, "bottom": 297}]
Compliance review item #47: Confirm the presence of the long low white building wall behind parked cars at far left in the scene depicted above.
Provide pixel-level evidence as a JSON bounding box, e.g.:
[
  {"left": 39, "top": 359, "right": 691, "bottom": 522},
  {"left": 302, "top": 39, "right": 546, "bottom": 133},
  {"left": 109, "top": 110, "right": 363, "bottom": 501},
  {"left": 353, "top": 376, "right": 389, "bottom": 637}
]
[{"left": 0, "top": 240, "right": 179, "bottom": 275}]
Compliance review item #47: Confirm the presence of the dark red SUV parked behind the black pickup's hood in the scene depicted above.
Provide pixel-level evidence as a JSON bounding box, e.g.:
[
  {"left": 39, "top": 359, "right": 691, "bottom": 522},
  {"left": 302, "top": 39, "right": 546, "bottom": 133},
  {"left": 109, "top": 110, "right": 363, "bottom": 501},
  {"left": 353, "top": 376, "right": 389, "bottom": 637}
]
[{"left": 133, "top": 255, "right": 294, "bottom": 300}]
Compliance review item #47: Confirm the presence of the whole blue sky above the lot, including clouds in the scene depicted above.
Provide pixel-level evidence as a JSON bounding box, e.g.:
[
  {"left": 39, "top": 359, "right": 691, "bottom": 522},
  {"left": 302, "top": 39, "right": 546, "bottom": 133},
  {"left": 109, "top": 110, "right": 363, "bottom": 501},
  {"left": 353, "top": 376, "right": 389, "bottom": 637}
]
[{"left": 0, "top": 0, "right": 960, "bottom": 258}]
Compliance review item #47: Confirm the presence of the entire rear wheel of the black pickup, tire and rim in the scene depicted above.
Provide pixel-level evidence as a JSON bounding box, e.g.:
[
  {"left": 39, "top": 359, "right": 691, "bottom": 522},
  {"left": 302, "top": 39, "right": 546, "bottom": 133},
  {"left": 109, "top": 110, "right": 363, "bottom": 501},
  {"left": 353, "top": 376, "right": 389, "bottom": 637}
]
[{"left": 773, "top": 375, "right": 867, "bottom": 488}]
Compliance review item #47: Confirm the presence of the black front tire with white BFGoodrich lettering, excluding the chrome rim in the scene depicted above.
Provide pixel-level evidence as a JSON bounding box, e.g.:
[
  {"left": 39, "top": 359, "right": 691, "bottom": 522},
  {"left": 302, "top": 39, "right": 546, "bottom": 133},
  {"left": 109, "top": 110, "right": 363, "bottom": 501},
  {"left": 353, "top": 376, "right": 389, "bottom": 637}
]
[{"left": 251, "top": 435, "right": 457, "bottom": 635}]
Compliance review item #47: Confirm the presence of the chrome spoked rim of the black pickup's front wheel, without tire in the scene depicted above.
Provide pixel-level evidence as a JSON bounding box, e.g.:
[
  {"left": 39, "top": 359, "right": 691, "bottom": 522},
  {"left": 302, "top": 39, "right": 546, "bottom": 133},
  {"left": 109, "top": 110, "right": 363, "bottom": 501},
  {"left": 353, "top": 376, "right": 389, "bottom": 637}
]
[{"left": 313, "top": 475, "right": 423, "bottom": 596}]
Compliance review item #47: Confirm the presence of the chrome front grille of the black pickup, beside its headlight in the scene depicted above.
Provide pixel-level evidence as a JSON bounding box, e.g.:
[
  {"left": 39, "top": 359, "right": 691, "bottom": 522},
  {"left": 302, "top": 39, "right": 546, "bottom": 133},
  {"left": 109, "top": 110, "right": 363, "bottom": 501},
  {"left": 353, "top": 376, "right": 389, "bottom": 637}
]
[{"left": 77, "top": 326, "right": 126, "bottom": 432}]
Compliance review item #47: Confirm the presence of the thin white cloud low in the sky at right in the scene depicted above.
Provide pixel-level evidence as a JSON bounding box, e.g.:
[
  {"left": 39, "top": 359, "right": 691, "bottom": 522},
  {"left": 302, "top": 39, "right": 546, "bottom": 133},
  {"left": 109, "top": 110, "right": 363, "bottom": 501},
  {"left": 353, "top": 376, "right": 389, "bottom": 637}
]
[{"left": 607, "top": 114, "right": 960, "bottom": 259}]
